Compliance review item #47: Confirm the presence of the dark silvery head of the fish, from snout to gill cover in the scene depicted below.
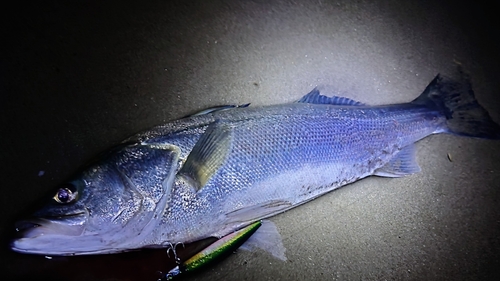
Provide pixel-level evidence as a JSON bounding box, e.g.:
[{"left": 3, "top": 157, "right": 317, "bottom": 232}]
[{"left": 11, "top": 145, "right": 178, "bottom": 255}]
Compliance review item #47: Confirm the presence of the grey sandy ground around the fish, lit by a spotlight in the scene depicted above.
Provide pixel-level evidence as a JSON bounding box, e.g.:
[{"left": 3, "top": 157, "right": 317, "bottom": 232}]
[{"left": 0, "top": 0, "right": 500, "bottom": 281}]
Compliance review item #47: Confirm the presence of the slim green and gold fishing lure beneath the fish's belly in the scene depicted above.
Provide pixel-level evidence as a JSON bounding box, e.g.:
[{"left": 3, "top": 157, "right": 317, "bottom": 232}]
[{"left": 162, "top": 221, "right": 262, "bottom": 280}]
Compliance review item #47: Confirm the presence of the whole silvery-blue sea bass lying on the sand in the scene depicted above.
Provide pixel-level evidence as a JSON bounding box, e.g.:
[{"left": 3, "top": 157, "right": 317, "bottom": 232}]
[{"left": 11, "top": 71, "right": 500, "bottom": 255}]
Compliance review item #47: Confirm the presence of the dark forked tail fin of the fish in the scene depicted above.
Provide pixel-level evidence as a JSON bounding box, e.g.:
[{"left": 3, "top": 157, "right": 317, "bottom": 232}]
[{"left": 412, "top": 71, "right": 500, "bottom": 139}]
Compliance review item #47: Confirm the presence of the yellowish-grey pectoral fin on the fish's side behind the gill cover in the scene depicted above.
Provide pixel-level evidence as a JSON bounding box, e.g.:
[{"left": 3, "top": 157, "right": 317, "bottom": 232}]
[{"left": 178, "top": 123, "right": 232, "bottom": 191}]
